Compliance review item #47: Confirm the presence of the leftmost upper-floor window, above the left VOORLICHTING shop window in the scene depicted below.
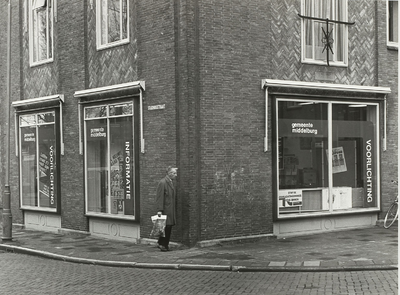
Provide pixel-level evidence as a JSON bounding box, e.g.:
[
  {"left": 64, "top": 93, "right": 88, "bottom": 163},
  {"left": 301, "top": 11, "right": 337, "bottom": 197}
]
[{"left": 29, "top": 0, "right": 54, "bottom": 65}]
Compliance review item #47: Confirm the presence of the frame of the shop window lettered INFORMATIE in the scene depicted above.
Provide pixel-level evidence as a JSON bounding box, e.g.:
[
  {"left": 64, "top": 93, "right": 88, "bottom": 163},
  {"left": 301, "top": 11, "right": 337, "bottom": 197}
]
[{"left": 82, "top": 99, "right": 139, "bottom": 221}]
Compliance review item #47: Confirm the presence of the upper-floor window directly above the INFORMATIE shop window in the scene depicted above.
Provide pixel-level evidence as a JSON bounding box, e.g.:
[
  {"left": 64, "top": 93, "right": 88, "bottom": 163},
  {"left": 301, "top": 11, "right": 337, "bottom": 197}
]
[{"left": 96, "top": 0, "right": 129, "bottom": 49}]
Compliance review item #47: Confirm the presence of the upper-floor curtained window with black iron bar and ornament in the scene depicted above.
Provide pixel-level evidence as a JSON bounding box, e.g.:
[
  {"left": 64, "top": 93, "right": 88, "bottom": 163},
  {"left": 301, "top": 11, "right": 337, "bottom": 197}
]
[{"left": 302, "top": 0, "right": 347, "bottom": 65}]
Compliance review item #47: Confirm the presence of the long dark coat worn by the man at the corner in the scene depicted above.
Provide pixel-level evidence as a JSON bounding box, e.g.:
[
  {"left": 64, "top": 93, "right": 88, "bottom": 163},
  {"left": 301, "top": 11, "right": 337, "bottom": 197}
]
[{"left": 156, "top": 177, "right": 176, "bottom": 225}]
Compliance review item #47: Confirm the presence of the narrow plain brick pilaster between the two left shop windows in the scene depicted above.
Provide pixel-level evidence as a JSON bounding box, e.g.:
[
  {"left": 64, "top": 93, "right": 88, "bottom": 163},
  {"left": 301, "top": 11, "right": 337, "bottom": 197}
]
[{"left": 55, "top": 0, "right": 88, "bottom": 231}]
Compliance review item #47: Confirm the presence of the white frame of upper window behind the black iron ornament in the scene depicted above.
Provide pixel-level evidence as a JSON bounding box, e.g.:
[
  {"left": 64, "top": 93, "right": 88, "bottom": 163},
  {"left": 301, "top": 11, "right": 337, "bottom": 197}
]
[{"left": 301, "top": 0, "right": 348, "bottom": 67}]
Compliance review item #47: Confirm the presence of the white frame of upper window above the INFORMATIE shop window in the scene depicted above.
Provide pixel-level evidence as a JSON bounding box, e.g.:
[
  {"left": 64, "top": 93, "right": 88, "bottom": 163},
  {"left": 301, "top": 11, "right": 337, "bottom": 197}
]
[{"left": 96, "top": 0, "right": 130, "bottom": 50}]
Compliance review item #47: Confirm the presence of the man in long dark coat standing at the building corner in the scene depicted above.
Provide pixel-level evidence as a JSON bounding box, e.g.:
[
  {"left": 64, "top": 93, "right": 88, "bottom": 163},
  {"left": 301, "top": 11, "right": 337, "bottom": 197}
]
[{"left": 156, "top": 166, "right": 178, "bottom": 252}]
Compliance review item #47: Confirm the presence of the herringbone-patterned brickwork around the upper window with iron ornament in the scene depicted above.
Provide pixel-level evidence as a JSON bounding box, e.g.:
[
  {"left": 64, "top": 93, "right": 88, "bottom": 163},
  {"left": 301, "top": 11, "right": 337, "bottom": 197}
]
[{"left": 269, "top": 0, "right": 376, "bottom": 86}]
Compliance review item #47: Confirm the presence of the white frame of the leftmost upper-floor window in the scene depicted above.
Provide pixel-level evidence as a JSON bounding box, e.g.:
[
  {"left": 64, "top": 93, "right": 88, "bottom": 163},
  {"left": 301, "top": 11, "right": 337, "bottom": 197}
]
[{"left": 28, "top": 0, "right": 56, "bottom": 66}]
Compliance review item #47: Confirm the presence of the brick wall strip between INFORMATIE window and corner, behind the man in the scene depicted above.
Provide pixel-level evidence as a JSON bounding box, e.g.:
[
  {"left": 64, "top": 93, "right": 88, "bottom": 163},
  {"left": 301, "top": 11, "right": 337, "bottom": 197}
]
[{"left": 138, "top": 0, "right": 180, "bottom": 241}]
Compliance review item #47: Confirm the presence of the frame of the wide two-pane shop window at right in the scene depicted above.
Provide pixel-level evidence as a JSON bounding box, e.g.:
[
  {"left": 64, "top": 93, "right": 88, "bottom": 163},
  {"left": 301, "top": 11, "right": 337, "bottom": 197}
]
[{"left": 273, "top": 95, "right": 381, "bottom": 220}]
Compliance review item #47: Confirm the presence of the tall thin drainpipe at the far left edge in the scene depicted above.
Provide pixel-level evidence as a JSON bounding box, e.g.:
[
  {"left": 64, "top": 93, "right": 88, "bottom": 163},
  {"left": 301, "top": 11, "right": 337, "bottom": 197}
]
[{"left": 2, "top": 0, "right": 12, "bottom": 240}]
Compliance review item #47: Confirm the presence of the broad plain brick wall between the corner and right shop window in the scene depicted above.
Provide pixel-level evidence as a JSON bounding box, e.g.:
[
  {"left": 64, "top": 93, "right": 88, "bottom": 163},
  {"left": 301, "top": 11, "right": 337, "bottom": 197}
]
[{"left": 197, "top": 1, "right": 272, "bottom": 240}]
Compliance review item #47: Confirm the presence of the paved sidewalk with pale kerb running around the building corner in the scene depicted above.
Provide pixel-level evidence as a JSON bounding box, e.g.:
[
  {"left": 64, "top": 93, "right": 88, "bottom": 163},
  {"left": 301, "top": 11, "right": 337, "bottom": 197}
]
[{"left": 0, "top": 225, "right": 398, "bottom": 272}]
